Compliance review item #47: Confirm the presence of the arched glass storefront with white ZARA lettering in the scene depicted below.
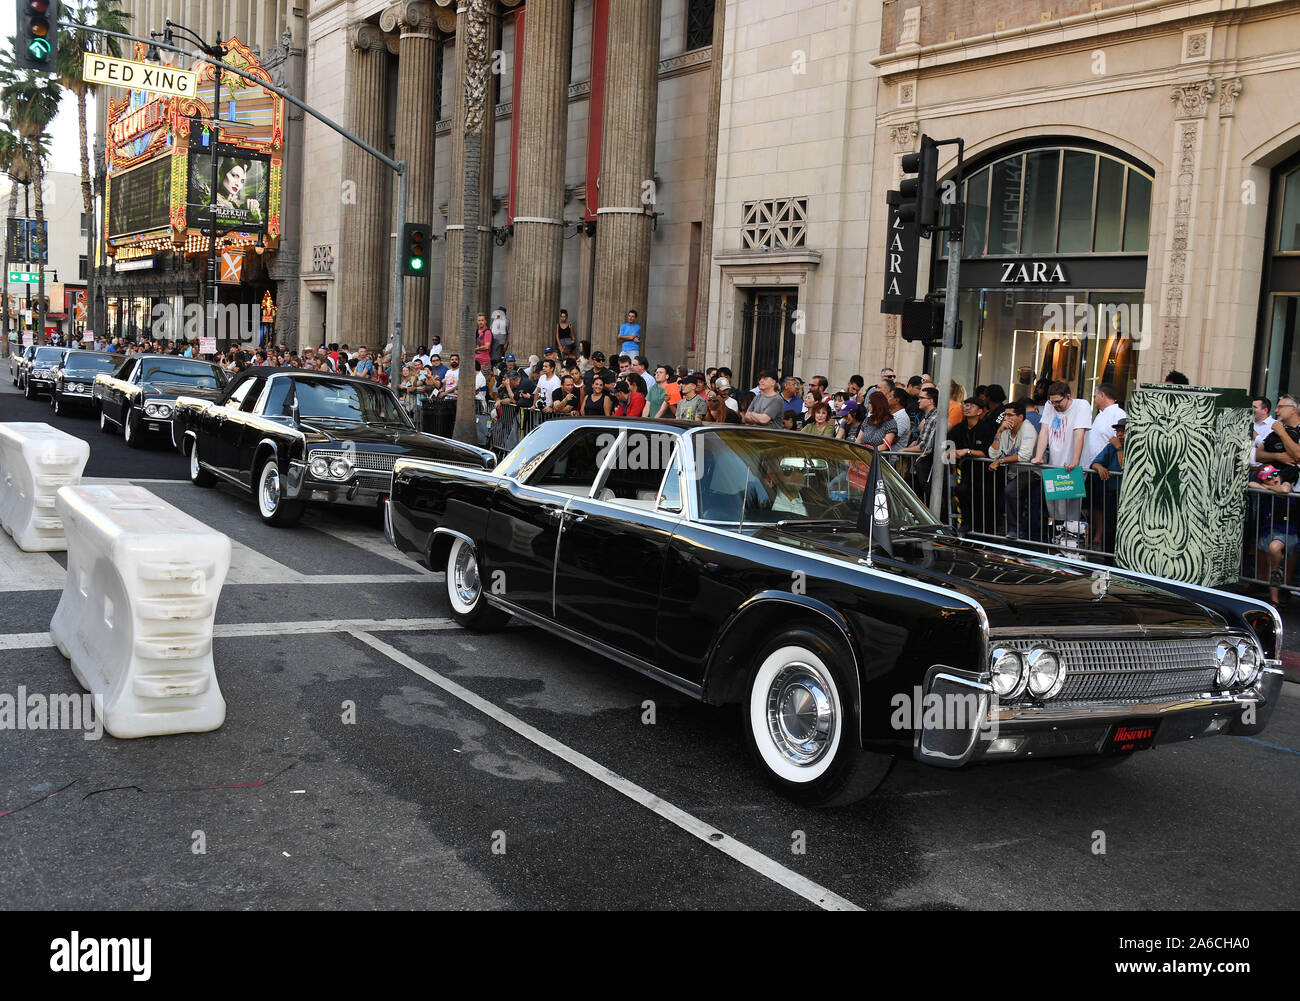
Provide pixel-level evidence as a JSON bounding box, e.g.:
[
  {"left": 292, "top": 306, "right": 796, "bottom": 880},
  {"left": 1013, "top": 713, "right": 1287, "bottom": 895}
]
[{"left": 926, "top": 144, "right": 1154, "bottom": 400}]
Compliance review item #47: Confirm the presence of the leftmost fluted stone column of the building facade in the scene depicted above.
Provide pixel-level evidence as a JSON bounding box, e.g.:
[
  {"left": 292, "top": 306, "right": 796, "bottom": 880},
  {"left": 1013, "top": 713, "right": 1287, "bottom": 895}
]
[{"left": 339, "top": 23, "right": 393, "bottom": 345}]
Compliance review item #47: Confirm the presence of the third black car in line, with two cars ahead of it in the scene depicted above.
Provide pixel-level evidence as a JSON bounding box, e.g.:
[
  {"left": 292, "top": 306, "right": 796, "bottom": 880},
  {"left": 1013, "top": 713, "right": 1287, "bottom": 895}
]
[{"left": 94, "top": 355, "right": 230, "bottom": 449}]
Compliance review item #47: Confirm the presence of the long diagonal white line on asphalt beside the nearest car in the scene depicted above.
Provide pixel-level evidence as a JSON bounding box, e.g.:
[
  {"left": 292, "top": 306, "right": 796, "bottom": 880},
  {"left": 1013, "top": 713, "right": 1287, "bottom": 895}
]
[{"left": 355, "top": 632, "right": 862, "bottom": 910}]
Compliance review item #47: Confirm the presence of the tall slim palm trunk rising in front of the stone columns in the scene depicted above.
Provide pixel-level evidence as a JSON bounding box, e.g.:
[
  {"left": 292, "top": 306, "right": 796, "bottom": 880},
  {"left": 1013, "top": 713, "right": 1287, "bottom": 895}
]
[{"left": 452, "top": 0, "right": 493, "bottom": 443}]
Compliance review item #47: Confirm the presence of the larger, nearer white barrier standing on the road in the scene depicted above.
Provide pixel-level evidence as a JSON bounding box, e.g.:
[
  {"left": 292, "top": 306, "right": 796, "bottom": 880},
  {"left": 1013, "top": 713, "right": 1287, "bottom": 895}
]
[{"left": 49, "top": 485, "right": 230, "bottom": 737}]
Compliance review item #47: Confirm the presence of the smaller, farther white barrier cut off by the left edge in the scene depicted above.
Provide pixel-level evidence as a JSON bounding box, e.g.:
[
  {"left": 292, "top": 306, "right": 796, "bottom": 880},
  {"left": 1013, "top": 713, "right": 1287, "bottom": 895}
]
[{"left": 0, "top": 423, "right": 90, "bottom": 553}]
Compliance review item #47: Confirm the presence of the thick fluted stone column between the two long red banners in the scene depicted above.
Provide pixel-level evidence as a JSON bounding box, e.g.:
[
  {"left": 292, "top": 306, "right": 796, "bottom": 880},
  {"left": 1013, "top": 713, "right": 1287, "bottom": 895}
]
[{"left": 506, "top": 0, "right": 573, "bottom": 358}]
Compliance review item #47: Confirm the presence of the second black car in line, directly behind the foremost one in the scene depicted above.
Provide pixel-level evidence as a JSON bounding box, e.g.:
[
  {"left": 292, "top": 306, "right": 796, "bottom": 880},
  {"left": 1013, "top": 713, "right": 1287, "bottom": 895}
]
[{"left": 176, "top": 368, "right": 497, "bottom": 525}]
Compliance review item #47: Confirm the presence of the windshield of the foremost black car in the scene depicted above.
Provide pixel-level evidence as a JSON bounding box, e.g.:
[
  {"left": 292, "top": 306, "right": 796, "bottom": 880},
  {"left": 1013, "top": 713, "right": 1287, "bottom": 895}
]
[{"left": 693, "top": 428, "right": 940, "bottom": 530}]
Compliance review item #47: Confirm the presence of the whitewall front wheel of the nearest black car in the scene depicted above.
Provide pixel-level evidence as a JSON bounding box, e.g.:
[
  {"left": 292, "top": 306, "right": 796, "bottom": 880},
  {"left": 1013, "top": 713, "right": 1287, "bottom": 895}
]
[{"left": 744, "top": 629, "right": 893, "bottom": 806}]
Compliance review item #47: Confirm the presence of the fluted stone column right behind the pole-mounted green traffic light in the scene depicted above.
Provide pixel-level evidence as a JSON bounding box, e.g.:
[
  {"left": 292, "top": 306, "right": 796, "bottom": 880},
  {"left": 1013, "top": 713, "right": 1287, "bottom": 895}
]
[{"left": 380, "top": 0, "right": 438, "bottom": 347}]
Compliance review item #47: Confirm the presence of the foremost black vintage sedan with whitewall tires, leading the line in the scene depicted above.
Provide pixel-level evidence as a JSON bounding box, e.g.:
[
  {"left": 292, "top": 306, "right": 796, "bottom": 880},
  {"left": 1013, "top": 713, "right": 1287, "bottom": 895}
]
[{"left": 385, "top": 419, "right": 1282, "bottom": 805}]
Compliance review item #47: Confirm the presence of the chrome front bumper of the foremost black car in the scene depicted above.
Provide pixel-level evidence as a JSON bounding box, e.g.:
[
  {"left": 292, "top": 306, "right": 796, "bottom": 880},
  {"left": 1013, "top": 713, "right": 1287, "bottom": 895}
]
[{"left": 913, "top": 662, "right": 1283, "bottom": 768}]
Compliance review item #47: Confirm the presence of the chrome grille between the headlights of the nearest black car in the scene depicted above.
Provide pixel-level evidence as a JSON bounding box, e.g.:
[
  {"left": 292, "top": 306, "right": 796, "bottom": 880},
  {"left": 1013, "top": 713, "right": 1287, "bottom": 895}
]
[{"left": 993, "top": 636, "right": 1217, "bottom": 706}]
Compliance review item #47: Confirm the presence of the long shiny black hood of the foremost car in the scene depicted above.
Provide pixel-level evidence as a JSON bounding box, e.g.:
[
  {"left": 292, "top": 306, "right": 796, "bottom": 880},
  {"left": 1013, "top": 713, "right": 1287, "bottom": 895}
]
[{"left": 755, "top": 525, "right": 1225, "bottom": 632}]
